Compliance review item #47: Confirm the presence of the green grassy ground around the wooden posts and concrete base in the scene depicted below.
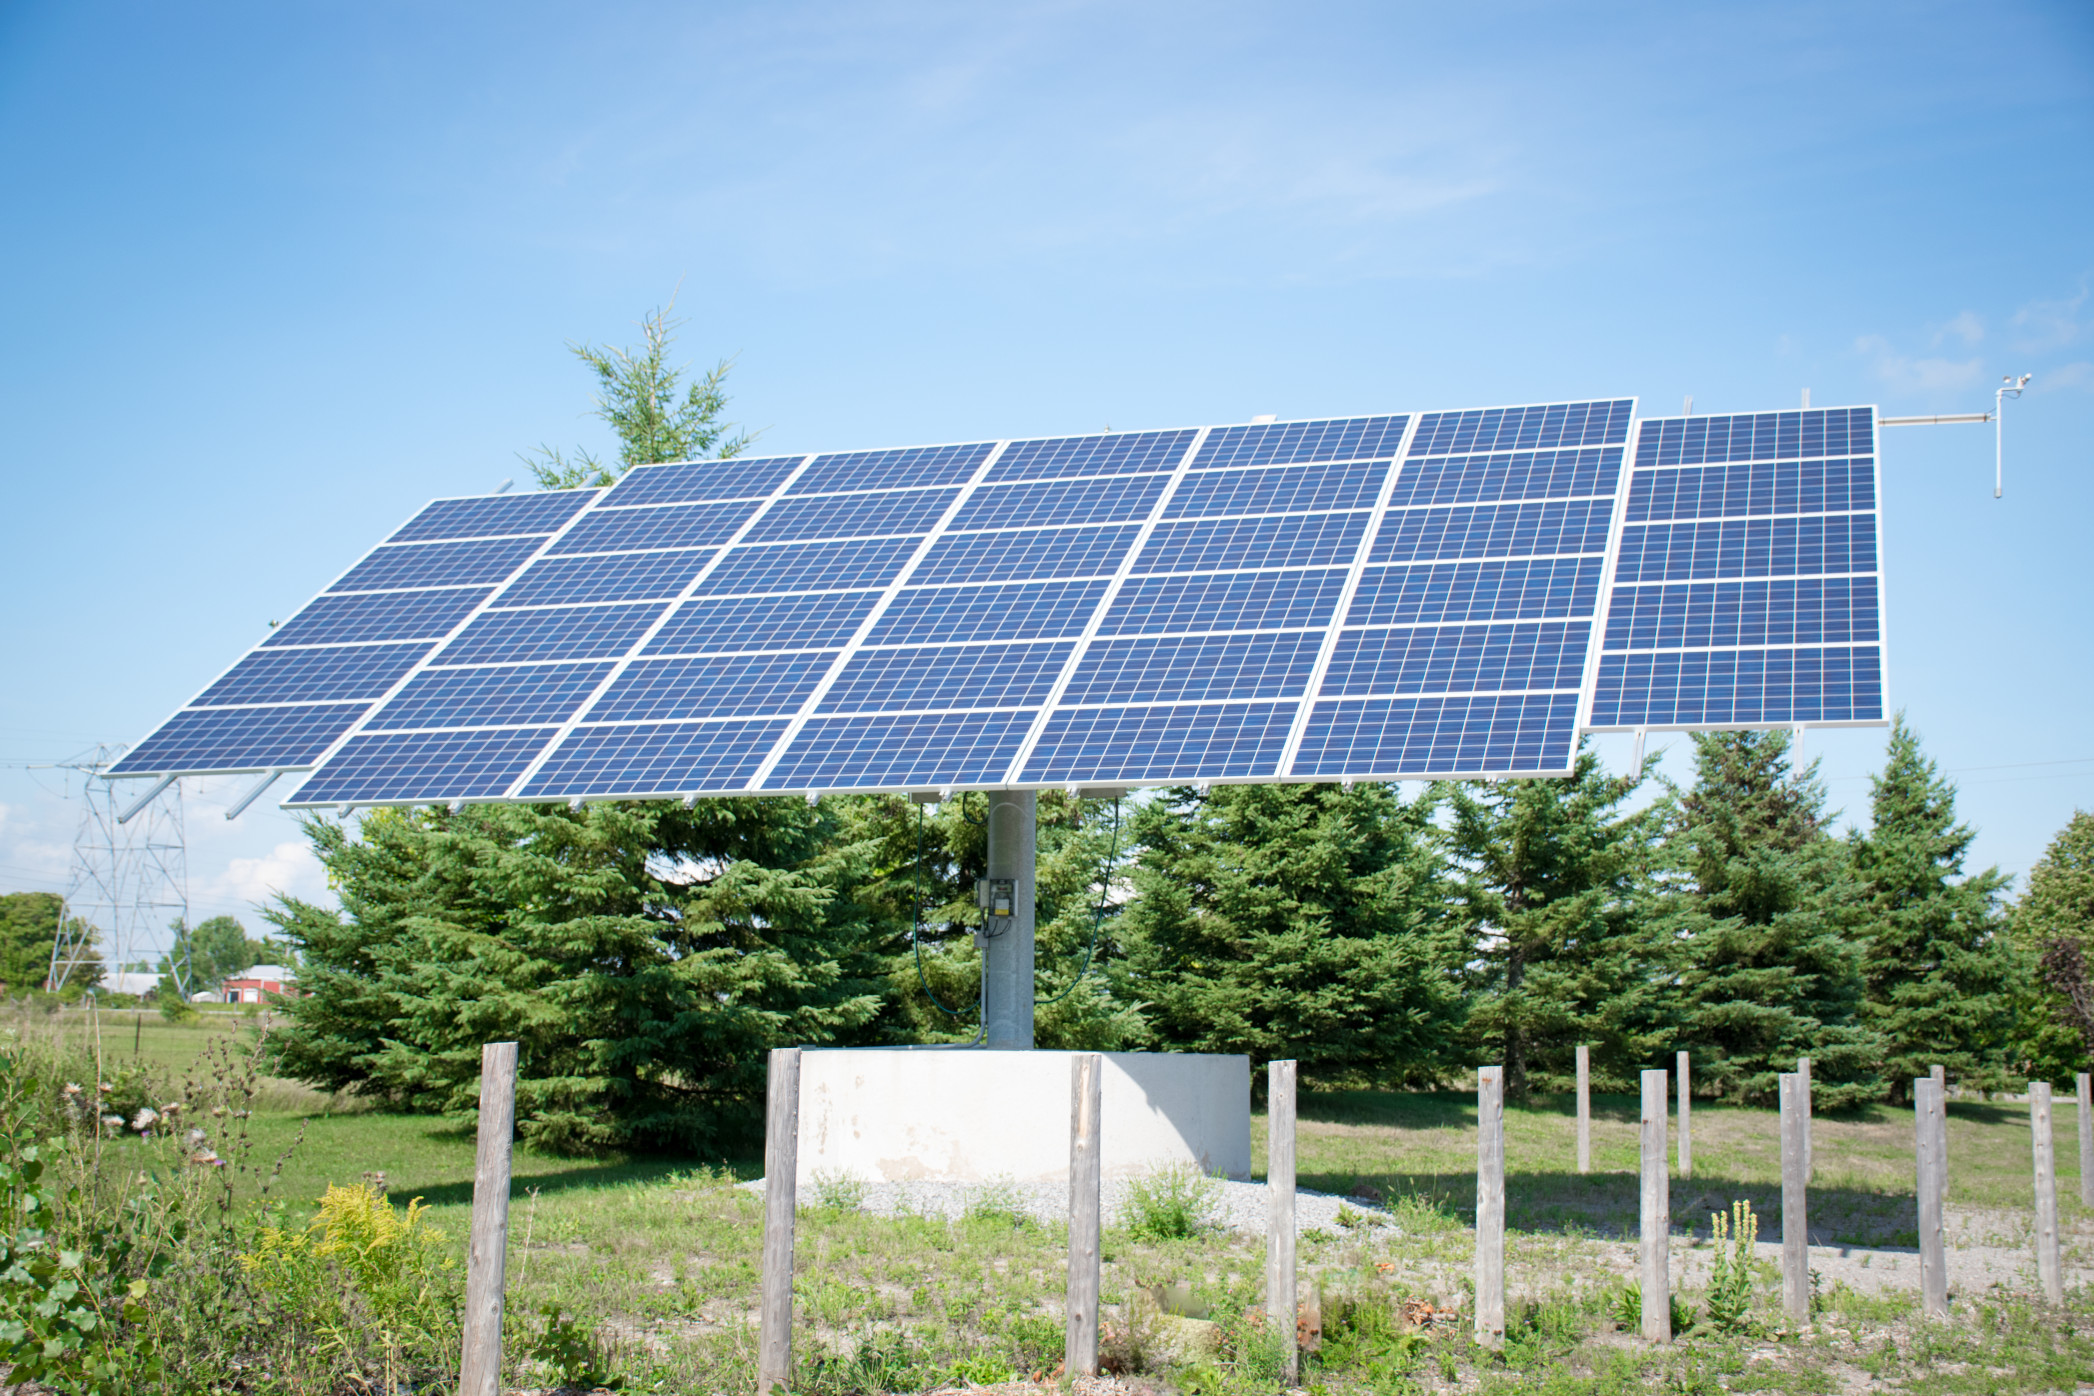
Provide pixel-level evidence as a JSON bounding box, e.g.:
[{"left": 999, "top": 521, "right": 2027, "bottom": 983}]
[{"left": 16, "top": 1013, "right": 2094, "bottom": 1396}]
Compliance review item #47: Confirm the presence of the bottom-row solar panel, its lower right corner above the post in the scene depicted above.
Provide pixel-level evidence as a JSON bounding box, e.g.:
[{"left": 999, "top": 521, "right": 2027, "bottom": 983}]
[{"left": 764, "top": 712, "right": 1034, "bottom": 789}]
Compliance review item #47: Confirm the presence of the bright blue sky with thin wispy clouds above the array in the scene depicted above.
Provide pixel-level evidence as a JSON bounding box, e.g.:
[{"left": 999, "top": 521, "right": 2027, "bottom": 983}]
[{"left": 0, "top": 2, "right": 2094, "bottom": 950}]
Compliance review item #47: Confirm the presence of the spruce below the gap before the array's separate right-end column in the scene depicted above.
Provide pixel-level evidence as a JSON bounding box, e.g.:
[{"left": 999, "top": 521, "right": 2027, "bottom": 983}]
[{"left": 1445, "top": 745, "right": 1669, "bottom": 1097}]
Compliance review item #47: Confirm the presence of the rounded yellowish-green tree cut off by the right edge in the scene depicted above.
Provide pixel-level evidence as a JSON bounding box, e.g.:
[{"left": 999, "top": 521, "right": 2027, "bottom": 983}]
[{"left": 2010, "top": 810, "right": 2094, "bottom": 1080}]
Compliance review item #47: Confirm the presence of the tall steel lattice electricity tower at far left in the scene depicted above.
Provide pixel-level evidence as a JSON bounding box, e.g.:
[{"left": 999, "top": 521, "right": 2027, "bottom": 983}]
[{"left": 46, "top": 743, "right": 191, "bottom": 998}]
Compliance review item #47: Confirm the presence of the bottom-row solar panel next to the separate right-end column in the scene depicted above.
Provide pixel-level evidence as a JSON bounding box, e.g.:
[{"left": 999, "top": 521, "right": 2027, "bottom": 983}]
[{"left": 1292, "top": 693, "right": 1577, "bottom": 779}]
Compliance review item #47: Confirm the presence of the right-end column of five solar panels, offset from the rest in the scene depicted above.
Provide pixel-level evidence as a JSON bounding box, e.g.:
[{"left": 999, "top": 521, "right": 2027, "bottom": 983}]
[{"left": 1587, "top": 408, "right": 1885, "bottom": 730}]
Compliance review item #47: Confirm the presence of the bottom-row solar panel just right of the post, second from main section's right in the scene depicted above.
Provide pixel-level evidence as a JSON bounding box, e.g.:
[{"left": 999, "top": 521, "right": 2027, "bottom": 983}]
[{"left": 1022, "top": 703, "right": 1300, "bottom": 785}]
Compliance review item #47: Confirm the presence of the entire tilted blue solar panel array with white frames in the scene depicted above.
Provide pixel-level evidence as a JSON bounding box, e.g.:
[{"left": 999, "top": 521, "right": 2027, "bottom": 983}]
[{"left": 115, "top": 400, "right": 1883, "bottom": 806}]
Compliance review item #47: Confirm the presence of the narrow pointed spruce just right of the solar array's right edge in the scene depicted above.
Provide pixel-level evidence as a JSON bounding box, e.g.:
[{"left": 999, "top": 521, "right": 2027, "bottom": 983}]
[{"left": 1853, "top": 714, "right": 2012, "bottom": 1103}]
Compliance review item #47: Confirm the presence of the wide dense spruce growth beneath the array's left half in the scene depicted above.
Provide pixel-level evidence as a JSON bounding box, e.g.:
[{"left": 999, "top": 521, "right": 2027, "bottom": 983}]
[{"left": 270, "top": 800, "right": 879, "bottom": 1151}]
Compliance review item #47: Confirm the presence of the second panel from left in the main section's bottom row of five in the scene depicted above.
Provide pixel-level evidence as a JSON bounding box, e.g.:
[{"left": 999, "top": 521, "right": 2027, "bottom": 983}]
[{"left": 521, "top": 722, "right": 785, "bottom": 800}]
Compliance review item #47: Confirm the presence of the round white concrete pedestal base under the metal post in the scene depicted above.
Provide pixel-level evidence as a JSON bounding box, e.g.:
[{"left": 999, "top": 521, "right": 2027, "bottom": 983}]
[{"left": 800, "top": 1046, "right": 1250, "bottom": 1187}]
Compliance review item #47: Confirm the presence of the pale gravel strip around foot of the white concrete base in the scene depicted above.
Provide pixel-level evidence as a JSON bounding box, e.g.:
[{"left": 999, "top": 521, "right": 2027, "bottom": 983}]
[{"left": 741, "top": 1178, "right": 1401, "bottom": 1235}]
